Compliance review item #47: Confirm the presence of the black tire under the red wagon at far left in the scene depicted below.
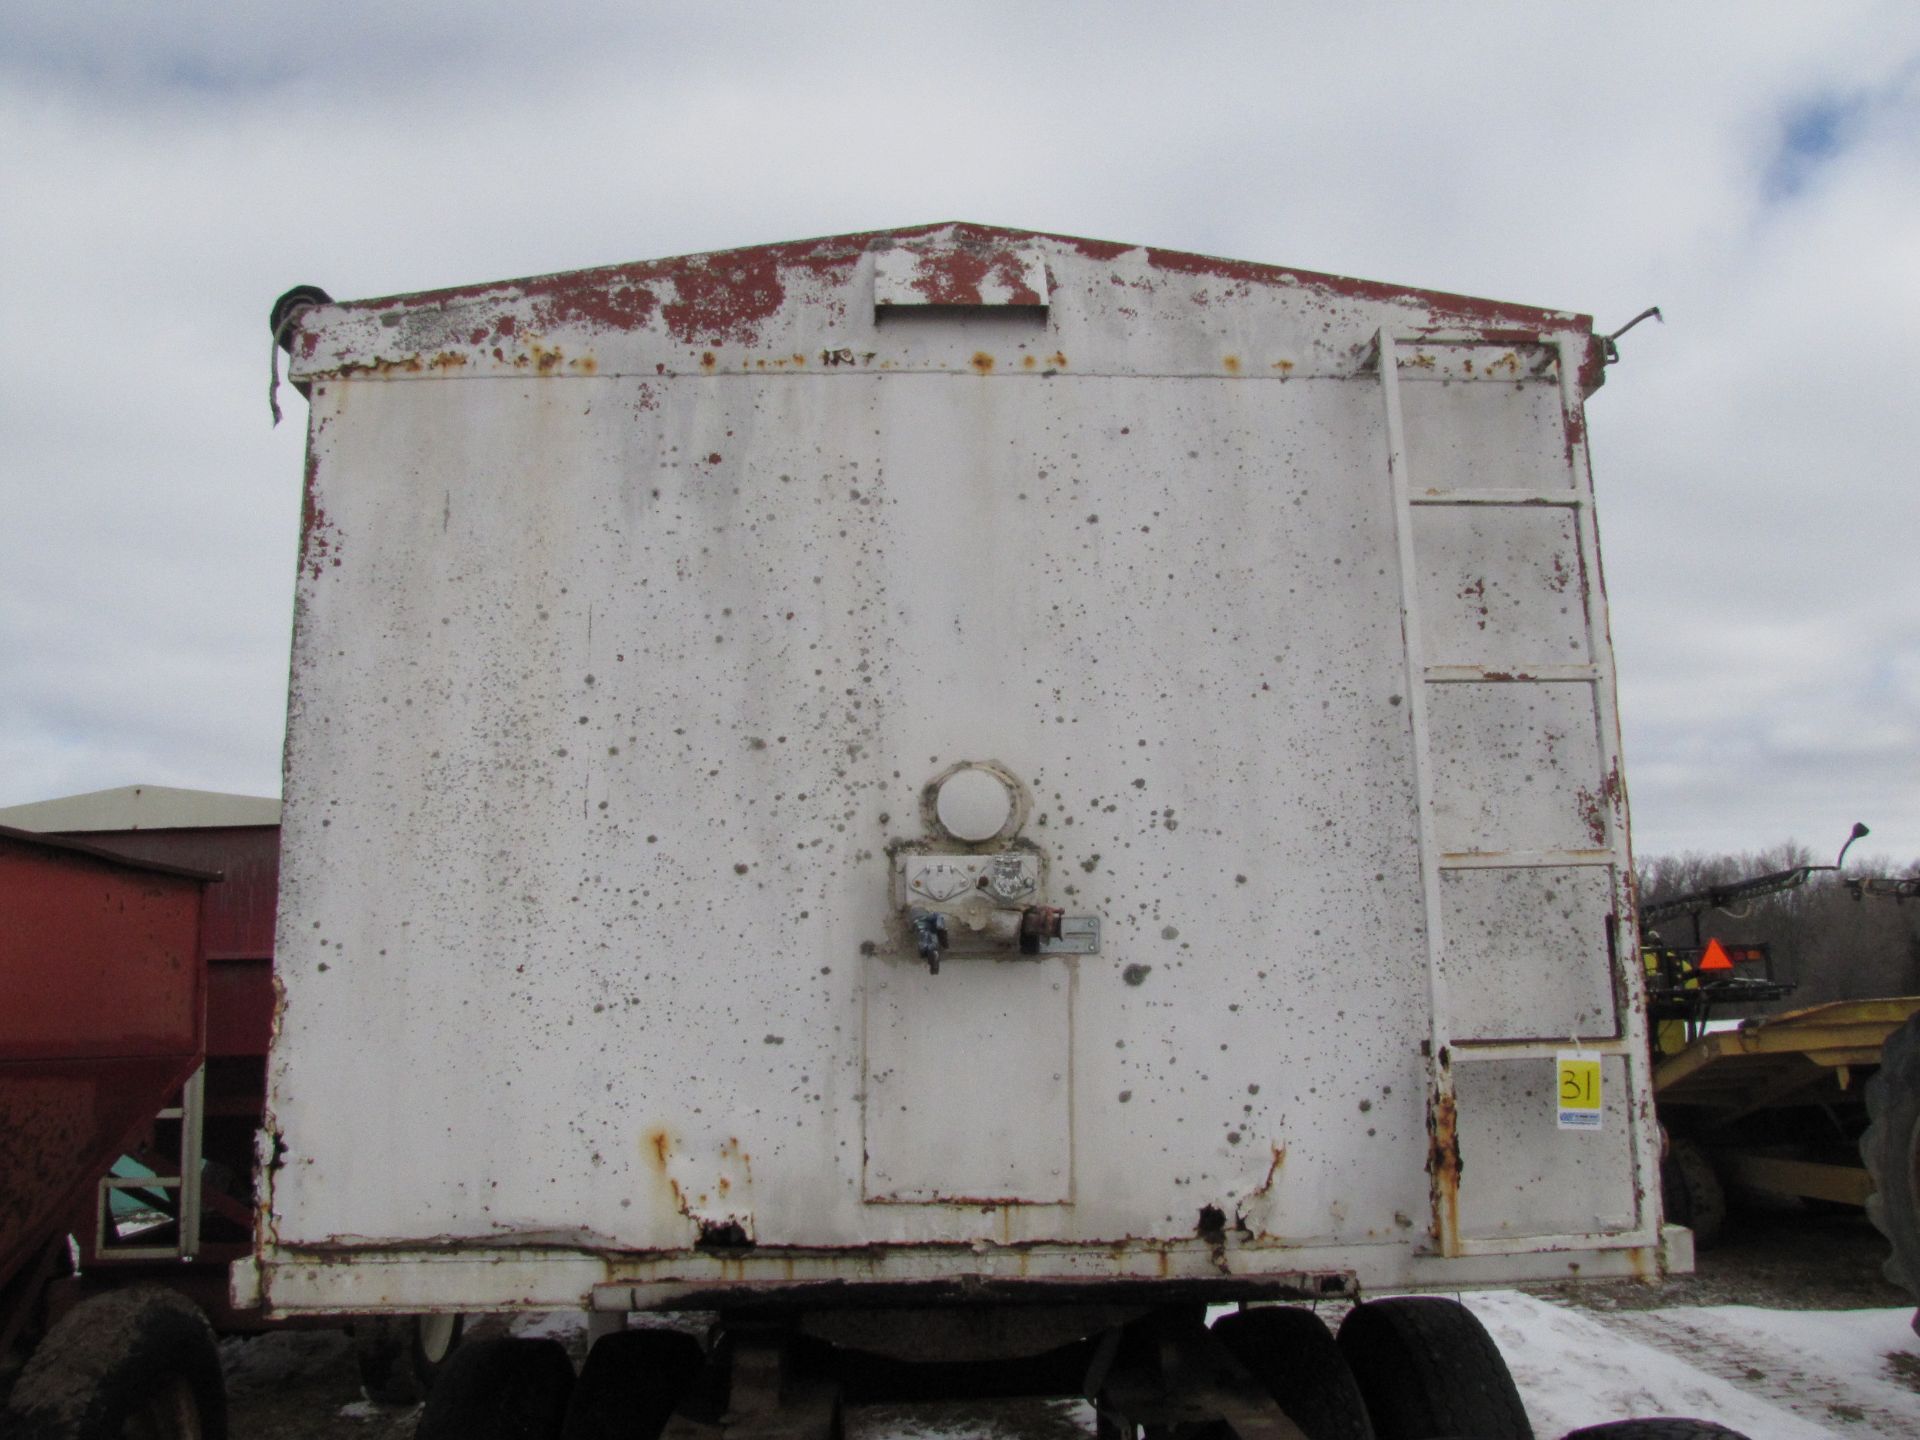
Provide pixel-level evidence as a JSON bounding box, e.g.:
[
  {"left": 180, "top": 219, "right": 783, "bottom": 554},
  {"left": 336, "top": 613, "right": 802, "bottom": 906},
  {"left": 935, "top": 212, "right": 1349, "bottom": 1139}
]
[{"left": 0, "top": 1284, "right": 227, "bottom": 1440}]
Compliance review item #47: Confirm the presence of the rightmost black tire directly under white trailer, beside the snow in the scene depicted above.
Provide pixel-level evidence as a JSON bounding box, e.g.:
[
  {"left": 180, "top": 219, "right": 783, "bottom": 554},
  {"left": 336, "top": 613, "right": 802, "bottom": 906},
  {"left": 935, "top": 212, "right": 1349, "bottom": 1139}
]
[{"left": 1340, "top": 1296, "right": 1534, "bottom": 1440}]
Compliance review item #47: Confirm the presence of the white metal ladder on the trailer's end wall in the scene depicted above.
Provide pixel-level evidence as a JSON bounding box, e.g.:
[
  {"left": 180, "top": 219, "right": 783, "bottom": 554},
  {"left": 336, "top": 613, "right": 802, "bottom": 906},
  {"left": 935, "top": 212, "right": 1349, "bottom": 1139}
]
[{"left": 1373, "top": 330, "right": 1659, "bottom": 1258}]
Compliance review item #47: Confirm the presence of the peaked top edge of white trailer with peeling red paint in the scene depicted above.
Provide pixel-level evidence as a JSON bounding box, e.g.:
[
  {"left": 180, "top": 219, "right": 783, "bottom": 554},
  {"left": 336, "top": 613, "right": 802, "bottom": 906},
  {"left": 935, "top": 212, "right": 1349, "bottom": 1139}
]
[{"left": 276, "top": 221, "right": 1601, "bottom": 390}]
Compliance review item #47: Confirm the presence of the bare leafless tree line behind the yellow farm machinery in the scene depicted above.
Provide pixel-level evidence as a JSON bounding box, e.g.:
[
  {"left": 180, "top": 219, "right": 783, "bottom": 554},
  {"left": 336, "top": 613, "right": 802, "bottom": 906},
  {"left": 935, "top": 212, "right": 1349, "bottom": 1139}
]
[{"left": 1636, "top": 841, "right": 1920, "bottom": 1014}]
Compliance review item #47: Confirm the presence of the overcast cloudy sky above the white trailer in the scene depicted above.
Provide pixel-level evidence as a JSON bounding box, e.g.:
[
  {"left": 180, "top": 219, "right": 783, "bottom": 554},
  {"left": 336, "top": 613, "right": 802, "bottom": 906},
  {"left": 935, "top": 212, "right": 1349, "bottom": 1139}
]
[{"left": 0, "top": 0, "right": 1920, "bottom": 862}]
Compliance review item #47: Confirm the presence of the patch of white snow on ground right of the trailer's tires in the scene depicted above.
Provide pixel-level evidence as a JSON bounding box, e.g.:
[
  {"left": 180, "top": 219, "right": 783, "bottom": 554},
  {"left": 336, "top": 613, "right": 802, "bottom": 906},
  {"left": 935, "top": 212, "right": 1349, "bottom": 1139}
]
[{"left": 1461, "top": 1290, "right": 1920, "bottom": 1440}]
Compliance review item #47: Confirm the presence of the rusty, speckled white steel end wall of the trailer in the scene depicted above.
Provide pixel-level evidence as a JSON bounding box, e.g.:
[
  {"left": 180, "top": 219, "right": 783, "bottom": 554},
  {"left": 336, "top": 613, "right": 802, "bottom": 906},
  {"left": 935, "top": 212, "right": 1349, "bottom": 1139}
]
[{"left": 257, "top": 227, "right": 1659, "bottom": 1311}]
